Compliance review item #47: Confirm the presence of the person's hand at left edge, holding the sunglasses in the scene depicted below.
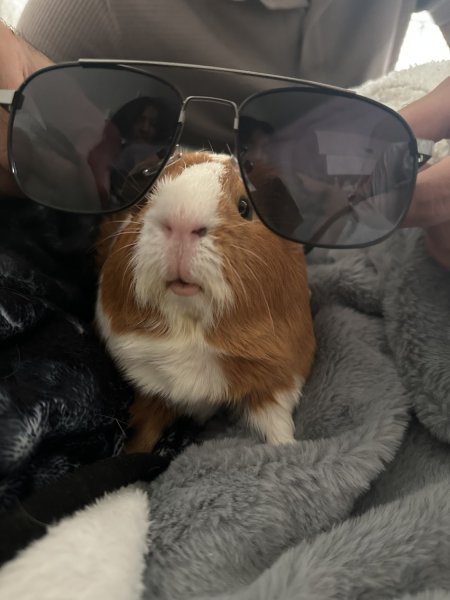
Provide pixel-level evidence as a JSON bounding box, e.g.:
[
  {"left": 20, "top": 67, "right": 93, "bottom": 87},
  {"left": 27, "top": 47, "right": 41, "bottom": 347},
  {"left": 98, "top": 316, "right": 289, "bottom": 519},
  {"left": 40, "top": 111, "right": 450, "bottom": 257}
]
[{"left": 0, "top": 21, "right": 51, "bottom": 195}]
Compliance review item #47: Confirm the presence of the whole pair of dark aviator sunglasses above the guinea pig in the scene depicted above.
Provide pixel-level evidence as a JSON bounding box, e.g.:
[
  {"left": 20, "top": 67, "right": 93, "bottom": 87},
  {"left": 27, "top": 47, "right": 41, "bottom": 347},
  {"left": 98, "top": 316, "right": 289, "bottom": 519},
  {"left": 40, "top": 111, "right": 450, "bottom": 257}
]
[{"left": 0, "top": 60, "right": 432, "bottom": 248}]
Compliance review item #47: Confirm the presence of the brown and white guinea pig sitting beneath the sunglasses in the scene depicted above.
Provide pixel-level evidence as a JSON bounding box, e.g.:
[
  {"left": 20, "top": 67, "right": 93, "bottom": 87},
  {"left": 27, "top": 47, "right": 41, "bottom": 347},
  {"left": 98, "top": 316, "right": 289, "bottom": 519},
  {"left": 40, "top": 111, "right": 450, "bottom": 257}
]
[{"left": 96, "top": 152, "right": 315, "bottom": 452}]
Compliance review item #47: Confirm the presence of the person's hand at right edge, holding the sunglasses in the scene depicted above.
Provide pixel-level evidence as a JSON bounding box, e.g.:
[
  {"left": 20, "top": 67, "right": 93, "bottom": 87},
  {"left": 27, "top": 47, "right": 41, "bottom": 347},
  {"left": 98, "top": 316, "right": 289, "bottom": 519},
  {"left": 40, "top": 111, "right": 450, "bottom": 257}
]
[{"left": 400, "top": 77, "right": 450, "bottom": 268}]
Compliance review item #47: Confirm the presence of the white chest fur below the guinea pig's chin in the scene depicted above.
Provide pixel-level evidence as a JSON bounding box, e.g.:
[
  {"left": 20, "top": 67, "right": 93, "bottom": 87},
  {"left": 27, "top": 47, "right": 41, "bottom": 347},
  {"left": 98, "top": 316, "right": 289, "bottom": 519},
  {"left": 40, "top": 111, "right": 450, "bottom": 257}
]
[{"left": 97, "top": 303, "right": 228, "bottom": 419}]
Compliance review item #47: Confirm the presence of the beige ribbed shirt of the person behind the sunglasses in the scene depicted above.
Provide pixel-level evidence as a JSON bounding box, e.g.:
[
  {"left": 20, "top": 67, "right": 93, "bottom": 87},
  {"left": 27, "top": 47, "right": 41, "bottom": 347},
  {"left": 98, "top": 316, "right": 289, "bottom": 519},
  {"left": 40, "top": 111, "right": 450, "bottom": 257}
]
[{"left": 18, "top": 0, "right": 450, "bottom": 87}]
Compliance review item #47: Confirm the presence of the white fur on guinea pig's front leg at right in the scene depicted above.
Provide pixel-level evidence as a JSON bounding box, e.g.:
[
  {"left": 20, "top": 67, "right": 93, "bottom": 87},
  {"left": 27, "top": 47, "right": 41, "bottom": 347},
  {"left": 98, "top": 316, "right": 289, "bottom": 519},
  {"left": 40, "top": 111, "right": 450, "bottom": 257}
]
[{"left": 246, "top": 377, "right": 304, "bottom": 444}]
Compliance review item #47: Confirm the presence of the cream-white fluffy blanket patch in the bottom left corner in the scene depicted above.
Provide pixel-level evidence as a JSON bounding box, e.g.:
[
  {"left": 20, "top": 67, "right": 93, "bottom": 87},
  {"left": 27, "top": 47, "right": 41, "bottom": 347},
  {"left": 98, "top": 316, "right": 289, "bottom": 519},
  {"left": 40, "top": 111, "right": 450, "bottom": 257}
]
[{"left": 0, "top": 487, "right": 149, "bottom": 600}]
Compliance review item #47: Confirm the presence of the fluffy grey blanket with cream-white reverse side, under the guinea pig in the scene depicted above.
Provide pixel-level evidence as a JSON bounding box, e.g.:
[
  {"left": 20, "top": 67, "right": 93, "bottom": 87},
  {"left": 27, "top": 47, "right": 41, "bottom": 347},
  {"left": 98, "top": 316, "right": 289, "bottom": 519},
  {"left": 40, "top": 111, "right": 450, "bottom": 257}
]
[{"left": 0, "top": 64, "right": 450, "bottom": 600}]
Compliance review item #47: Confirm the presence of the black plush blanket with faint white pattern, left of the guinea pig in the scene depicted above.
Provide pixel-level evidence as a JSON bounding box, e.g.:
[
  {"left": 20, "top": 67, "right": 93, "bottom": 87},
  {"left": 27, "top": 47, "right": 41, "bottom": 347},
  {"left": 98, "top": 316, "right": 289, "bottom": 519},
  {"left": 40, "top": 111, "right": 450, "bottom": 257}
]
[{"left": 0, "top": 198, "right": 130, "bottom": 508}]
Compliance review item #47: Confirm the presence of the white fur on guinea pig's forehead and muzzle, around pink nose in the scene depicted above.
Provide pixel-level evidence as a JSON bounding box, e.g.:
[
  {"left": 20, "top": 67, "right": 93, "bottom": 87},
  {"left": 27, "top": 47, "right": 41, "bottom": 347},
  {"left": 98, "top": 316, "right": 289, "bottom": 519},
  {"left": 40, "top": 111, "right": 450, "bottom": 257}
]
[{"left": 133, "top": 161, "right": 233, "bottom": 329}]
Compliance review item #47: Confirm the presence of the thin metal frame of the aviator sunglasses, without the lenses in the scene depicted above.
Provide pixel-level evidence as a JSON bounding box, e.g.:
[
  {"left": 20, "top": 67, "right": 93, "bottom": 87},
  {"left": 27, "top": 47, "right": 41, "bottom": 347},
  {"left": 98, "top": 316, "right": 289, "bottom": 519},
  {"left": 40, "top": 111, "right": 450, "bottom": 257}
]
[{"left": 0, "top": 58, "right": 434, "bottom": 249}]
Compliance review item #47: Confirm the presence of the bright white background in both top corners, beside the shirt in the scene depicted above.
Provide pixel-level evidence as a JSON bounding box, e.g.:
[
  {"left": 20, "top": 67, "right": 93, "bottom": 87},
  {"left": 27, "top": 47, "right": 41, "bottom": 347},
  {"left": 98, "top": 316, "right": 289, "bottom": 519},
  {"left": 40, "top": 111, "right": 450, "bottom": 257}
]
[{"left": 0, "top": 0, "right": 450, "bottom": 70}]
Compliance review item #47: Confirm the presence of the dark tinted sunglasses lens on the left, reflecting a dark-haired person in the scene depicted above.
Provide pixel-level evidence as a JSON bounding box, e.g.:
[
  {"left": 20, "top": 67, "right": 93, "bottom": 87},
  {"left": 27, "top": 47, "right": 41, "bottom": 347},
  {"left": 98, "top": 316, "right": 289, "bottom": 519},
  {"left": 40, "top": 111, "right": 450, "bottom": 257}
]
[{"left": 9, "top": 65, "right": 181, "bottom": 213}]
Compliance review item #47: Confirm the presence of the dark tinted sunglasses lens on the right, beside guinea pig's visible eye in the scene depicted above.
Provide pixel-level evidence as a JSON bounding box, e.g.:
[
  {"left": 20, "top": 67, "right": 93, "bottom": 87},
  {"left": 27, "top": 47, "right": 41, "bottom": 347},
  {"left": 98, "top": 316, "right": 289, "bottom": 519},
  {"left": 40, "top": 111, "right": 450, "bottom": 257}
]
[{"left": 238, "top": 88, "right": 417, "bottom": 247}]
